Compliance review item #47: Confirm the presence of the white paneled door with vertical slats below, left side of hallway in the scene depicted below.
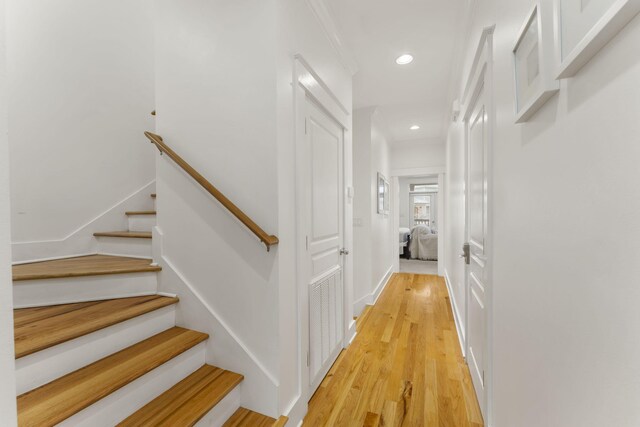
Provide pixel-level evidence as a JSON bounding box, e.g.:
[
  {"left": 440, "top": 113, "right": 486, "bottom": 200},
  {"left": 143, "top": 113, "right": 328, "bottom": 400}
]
[{"left": 305, "top": 98, "right": 344, "bottom": 395}]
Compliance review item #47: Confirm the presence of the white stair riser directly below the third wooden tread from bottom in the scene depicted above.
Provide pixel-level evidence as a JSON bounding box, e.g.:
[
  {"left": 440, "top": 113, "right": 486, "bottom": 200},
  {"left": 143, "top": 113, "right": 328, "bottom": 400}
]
[{"left": 58, "top": 343, "right": 205, "bottom": 427}]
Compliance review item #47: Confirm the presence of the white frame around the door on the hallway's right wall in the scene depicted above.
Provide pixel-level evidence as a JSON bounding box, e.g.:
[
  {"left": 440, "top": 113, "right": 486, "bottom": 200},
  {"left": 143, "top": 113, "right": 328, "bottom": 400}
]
[{"left": 462, "top": 26, "right": 495, "bottom": 426}]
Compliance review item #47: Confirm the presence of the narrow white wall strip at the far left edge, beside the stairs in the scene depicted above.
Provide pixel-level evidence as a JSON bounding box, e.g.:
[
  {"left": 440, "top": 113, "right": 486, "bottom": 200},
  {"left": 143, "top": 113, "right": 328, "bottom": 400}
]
[{"left": 0, "top": 0, "right": 17, "bottom": 426}]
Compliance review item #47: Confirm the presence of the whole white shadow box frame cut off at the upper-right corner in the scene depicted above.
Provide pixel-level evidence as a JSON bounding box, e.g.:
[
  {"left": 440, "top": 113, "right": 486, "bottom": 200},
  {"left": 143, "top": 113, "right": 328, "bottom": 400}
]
[{"left": 554, "top": 0, "right": 640, "bottom": 79}]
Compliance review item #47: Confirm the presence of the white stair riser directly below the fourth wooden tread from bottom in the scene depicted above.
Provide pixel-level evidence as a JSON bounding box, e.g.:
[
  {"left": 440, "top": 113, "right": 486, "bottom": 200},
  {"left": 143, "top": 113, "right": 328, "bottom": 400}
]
[{"left": 16, "top": 305, "right": 176, "bottom": 395}]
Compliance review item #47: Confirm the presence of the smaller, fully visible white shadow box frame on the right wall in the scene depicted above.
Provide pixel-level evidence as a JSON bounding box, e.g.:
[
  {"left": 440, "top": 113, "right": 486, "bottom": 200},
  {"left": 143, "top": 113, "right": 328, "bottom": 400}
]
[{"left": 512, "top": 1, "right": 560, "bottom": 123}]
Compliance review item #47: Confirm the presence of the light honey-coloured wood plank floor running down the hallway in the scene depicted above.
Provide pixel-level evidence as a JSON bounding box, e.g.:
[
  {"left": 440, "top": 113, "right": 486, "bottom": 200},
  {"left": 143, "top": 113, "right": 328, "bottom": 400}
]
[{"left": 304, "top": 273, "right": 483, "bottom": 427}]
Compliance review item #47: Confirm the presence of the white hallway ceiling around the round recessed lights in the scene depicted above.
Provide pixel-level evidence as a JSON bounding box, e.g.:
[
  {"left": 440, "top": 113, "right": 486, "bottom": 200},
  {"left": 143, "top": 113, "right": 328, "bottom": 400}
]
[{"left": 326, "top": 0, "right": 468, "bottom": 141}]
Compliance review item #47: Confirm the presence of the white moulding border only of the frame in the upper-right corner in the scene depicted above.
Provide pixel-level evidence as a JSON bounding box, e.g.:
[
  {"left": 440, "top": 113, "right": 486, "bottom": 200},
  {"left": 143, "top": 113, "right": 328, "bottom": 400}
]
[{"left": 554, "top": 0, "right": 640, "bottom": 79}]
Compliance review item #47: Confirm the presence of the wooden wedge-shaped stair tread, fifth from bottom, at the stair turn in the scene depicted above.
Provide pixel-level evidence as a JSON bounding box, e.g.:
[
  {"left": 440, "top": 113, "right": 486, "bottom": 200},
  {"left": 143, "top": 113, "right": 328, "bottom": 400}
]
[{"left": 13, "top": 255, "right": 162, "bottom": 281}]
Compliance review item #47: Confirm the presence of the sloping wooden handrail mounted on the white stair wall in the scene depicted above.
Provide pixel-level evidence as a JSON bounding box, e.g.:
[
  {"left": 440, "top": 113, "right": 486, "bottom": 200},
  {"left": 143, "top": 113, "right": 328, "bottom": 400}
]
[{"left": 144, "top": 132, "right": 278, "bottom": 251}]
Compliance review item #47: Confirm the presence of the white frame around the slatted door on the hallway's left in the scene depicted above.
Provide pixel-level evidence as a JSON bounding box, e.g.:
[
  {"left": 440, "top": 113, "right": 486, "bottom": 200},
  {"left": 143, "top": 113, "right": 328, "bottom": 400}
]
[{"left": 293, "top": 55, "right": 356, "bottom": 413}]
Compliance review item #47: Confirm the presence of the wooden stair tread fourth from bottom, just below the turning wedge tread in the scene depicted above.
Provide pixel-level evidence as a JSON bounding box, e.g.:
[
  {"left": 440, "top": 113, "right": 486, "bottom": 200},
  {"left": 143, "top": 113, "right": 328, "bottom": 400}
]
[{"left": 13, "top": 295, "right": 178, "bottom": 359}]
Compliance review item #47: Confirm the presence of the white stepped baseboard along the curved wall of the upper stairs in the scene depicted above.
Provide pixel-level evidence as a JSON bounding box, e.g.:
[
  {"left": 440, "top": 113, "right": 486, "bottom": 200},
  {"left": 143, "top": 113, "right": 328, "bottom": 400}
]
[{"left": 11, "top": 181, "right": 155, "bottom": 264}]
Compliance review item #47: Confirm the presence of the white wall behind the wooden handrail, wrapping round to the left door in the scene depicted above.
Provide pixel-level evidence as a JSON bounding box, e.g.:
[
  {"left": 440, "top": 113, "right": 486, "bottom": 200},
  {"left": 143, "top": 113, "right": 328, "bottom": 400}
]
[{"left": 156, "top": 0, "right": 351, "bottom": 418}]
